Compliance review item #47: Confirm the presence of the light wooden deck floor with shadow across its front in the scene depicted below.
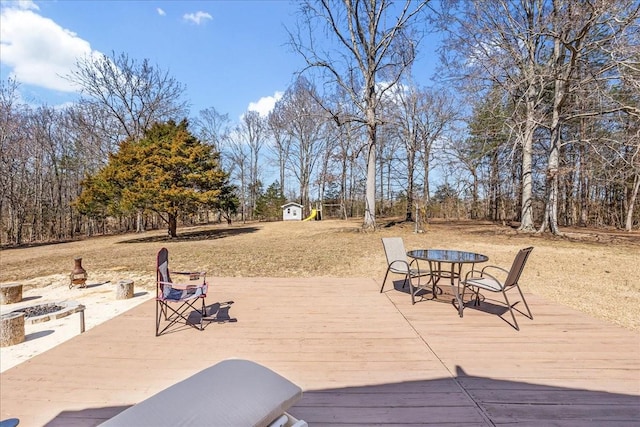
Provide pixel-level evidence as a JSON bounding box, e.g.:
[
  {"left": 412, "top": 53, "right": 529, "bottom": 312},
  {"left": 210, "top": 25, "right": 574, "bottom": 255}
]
[{"left": 0, "top": 278, "right": 640, "bottom": 427}]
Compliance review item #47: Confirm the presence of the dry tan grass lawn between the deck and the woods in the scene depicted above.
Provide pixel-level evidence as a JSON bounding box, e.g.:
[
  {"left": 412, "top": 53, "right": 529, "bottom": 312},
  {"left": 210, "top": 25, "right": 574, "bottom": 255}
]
[{"left": 0, "top": 220, "right": 640, "bottom": 330}]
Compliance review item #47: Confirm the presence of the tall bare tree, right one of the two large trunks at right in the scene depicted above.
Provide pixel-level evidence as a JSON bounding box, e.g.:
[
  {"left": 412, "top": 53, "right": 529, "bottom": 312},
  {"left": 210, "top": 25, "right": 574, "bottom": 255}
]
[{"left": 540, "top": 0, "right": 640, "bottom": 234}]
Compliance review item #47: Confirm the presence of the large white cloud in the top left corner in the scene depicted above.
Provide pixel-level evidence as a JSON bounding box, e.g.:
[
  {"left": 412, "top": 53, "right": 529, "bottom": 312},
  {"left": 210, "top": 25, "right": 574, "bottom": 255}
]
[{"left": 0, "top": 5, "right": 91, "bottom": 92}]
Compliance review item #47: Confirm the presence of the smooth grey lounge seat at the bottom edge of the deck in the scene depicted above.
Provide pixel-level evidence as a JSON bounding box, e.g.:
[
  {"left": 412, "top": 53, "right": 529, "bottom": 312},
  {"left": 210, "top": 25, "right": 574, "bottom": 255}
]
[{"left": 100, "top": 359, "right": 307, "bottom": 427}]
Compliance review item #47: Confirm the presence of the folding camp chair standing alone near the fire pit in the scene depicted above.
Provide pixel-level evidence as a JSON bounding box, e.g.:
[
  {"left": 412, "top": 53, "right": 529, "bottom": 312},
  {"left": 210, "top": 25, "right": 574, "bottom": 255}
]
[{"left": 156, "top": 248, "right": 208, "bottom": 336}]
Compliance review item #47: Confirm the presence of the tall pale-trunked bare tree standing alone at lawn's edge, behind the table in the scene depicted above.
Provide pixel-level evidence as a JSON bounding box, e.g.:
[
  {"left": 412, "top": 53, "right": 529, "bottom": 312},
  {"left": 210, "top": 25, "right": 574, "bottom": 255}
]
[{"left": 290, "top": 0, "right": 428, "bottom": 229}]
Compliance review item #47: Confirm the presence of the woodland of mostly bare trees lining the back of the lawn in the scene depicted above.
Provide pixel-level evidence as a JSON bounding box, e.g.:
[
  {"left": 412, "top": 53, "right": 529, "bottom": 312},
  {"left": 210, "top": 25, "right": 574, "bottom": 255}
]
[{"left": 0, "top": 0, "right": 640, "bottom": 245}]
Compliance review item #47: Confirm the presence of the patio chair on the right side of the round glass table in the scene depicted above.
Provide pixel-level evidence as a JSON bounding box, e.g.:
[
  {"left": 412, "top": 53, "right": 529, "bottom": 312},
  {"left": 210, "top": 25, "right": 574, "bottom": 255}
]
[{"left": 460, "top": 247, "right": 533, "bottom": 331}]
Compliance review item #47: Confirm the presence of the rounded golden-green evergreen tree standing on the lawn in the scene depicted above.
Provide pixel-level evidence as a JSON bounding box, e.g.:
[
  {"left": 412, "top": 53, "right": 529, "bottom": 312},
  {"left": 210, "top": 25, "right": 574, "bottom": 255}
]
[{"left": 76, "top": 120, "right": 228, "bottom": 237}]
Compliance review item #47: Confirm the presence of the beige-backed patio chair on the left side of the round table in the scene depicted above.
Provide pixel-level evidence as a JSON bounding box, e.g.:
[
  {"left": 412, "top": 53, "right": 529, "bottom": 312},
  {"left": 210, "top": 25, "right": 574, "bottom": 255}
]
[{"left": 380, "top": 237, "right": 435, "bottom": 304}]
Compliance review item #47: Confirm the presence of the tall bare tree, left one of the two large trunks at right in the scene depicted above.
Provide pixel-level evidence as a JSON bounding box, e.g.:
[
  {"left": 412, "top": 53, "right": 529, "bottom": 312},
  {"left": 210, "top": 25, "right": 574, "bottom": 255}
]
[{"left": 441, "top": 0, "right": 547, "bottom": 231}]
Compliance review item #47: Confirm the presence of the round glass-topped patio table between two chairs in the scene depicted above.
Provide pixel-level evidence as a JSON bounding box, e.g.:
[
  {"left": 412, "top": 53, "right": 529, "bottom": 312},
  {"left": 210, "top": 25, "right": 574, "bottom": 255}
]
[{"left": 407, "top": 249, "right": 489, "bottom": 317}]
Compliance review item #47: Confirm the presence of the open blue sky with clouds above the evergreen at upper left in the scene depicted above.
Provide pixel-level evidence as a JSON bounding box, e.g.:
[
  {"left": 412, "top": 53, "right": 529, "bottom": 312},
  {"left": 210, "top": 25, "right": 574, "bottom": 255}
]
[{"left": 0, "top": 0, "right": 435, "bottom": 121}]
